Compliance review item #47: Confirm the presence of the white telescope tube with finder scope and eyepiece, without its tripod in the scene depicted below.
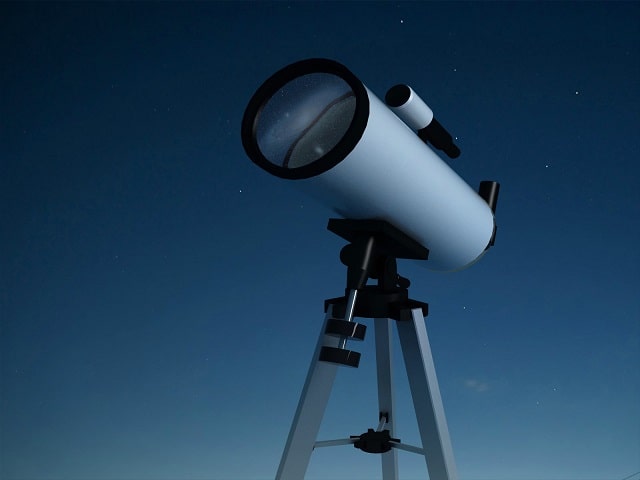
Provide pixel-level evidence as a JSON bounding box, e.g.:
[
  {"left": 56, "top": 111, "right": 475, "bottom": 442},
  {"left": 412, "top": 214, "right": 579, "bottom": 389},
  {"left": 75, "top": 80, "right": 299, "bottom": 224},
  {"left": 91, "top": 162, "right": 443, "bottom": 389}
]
[{"left": 242, "top": 59, "right": 499, "bottom": 271}]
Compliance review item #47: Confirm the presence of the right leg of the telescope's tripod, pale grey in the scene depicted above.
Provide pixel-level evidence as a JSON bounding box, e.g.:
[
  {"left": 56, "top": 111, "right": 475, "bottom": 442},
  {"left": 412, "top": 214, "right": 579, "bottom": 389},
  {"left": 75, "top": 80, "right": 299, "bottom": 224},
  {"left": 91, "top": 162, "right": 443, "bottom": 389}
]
[{"left": 397, "top": 308, "right": 458, "bottom": 480}]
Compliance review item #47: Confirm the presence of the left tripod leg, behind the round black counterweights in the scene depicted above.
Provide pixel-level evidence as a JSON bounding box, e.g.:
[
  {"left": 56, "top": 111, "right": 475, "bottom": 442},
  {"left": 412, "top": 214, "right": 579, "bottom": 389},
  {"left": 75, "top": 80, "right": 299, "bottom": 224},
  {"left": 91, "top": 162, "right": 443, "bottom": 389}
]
[{"left": 276, "top": 306, "right": 340, "bottom": 480}]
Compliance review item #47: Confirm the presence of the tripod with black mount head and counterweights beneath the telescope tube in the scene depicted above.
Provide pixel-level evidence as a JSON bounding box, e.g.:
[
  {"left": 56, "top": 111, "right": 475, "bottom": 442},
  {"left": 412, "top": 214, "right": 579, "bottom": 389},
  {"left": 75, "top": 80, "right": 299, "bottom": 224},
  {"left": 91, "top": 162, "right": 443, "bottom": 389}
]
[{"left": 276, "top": 219, "right": 457, "bottom": 480}]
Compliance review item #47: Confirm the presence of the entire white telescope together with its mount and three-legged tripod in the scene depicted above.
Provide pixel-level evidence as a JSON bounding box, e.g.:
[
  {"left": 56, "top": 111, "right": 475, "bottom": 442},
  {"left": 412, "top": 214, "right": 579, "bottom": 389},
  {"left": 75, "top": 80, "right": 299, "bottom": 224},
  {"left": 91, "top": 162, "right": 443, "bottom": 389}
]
[{"left": 241, "top": 58, "right": 499, "bottom": 480}]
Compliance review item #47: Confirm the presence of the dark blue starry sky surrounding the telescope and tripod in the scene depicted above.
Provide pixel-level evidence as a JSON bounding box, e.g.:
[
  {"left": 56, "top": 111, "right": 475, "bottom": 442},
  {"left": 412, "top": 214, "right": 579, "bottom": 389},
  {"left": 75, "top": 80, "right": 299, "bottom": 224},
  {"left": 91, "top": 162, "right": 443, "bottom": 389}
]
[{"left": 0, "top": 2, "right": 640, "bottom": 480}]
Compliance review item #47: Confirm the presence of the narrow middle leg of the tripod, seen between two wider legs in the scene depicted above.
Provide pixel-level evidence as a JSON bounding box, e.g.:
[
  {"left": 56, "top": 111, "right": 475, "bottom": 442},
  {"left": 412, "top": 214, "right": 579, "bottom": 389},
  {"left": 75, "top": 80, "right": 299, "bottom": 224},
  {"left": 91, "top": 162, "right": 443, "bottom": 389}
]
[{"left": 375, "top": 318, "right": 398, "bottom": 480}]
